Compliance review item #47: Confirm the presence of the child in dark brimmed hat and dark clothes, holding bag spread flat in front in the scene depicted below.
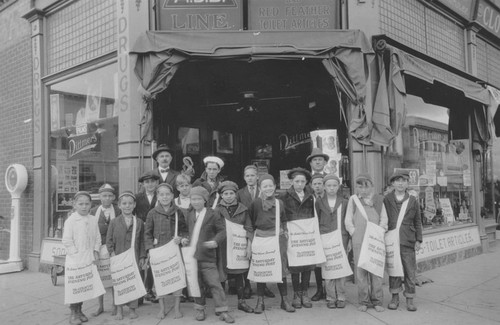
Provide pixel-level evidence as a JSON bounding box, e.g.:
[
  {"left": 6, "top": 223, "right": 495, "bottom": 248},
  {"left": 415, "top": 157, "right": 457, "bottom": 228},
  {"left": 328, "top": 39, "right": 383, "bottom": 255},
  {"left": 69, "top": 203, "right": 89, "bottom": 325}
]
[{"left": 280, "top": 168, "right": 316, "bottom": 308}]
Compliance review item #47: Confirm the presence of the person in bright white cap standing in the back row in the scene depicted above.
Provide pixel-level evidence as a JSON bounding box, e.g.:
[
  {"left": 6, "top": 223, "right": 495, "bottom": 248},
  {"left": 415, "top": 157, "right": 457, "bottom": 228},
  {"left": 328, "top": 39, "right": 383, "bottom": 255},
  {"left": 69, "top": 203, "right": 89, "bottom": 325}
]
[{"left": 193, "top": 156, "right": 224, "bottom": 209}]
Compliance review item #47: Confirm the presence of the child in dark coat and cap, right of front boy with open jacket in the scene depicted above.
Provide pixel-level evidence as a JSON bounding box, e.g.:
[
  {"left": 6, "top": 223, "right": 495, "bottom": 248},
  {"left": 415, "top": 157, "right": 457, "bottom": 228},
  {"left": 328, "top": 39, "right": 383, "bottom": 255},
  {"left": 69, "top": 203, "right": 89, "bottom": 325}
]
[{"left": 216, "top": 181, "right": 253, "bottom": 313}]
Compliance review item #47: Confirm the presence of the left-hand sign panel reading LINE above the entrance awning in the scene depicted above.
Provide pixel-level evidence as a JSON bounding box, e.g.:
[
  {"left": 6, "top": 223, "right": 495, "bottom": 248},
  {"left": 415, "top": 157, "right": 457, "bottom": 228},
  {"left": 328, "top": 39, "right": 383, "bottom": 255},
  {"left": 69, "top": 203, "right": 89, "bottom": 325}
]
[{"left": 156, "top": 0, "right": 243, "bottom": 31}]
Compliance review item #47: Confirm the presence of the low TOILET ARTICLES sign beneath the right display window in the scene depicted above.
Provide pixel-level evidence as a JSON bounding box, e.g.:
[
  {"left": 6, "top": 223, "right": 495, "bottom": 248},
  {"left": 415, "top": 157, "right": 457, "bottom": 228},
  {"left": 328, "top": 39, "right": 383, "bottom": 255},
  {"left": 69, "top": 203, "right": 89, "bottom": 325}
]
[{"left": 417, "top": 227, "right": 481, "bottom": 261}]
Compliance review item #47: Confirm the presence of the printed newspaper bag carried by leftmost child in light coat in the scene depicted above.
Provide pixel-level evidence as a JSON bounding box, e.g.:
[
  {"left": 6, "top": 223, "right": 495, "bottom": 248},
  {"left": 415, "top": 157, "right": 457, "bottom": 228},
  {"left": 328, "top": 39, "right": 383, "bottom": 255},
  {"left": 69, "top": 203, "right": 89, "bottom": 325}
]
[{"left": 64, "top": 263, "right": 106, "bottom": 304}]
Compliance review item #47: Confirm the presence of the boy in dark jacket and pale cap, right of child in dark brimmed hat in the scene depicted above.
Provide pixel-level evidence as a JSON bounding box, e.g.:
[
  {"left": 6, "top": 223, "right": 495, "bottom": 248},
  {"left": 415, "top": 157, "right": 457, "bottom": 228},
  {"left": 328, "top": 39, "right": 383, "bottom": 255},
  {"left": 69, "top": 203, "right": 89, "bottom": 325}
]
[{"left": 316, "top": 174, "right": 349, "bottom": 308}]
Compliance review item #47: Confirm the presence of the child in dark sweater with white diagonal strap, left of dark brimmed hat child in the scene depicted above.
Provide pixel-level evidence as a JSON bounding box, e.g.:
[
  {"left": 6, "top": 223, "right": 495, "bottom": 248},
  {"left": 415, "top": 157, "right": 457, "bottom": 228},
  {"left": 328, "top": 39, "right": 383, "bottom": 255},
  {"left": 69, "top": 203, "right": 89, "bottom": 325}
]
[{"left": 249, "top": 174, "right": 295, "bottom": 314}]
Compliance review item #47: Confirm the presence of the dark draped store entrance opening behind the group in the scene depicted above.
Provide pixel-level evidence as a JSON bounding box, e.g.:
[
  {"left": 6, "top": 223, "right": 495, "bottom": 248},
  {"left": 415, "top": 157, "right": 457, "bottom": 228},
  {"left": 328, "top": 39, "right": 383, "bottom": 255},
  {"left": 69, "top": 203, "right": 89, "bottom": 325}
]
[{"left": 153, "top": 60, "right": 347, "bottom": 185}]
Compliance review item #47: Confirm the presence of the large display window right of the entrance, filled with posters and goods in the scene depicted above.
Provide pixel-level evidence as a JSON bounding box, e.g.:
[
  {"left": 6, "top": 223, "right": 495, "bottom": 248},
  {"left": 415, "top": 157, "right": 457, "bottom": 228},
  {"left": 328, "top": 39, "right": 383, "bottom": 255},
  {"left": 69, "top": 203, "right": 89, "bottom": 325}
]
[{"left": 384, "top": 95, "right": 474, "bottom": 229}]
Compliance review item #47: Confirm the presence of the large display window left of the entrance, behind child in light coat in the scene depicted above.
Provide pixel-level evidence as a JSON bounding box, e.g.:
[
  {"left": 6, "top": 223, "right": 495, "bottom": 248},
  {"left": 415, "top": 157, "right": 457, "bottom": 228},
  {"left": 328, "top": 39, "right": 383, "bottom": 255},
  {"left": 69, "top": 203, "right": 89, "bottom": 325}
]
[{"left": 47, "top": 64, "right": 119, "bottom": 238}]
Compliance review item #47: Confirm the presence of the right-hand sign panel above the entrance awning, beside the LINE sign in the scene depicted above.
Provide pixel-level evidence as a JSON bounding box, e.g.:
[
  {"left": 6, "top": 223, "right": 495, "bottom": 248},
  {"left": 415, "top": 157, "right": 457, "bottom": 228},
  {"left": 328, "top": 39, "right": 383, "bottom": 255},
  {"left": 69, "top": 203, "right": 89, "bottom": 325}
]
[{"left": 248, "top": 0, "right": 340, "bottom": 31}]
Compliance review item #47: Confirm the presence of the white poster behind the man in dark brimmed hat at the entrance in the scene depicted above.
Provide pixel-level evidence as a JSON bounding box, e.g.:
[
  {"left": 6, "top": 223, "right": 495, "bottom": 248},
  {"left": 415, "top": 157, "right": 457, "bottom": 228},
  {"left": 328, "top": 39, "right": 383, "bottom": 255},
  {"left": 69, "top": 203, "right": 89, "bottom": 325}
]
[{"left": 311, "top": 129, "right": 342, "bottom": 177}]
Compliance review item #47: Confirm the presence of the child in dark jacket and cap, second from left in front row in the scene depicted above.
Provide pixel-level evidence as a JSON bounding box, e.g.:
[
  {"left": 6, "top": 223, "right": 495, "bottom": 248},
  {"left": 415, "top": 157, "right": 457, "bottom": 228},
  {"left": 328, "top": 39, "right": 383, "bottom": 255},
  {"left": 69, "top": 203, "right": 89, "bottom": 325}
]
[{"left": 106, "top": 191, "right": 146, "bottom": 320}]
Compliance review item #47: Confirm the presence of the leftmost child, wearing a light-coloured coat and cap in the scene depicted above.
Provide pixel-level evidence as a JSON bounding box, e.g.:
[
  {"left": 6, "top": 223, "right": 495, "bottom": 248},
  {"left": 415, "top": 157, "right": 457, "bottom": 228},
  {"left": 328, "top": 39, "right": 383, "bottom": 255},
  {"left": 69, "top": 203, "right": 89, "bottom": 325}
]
[{"left": 62, "top": 191, "right": 101, "bottom": 325}]
